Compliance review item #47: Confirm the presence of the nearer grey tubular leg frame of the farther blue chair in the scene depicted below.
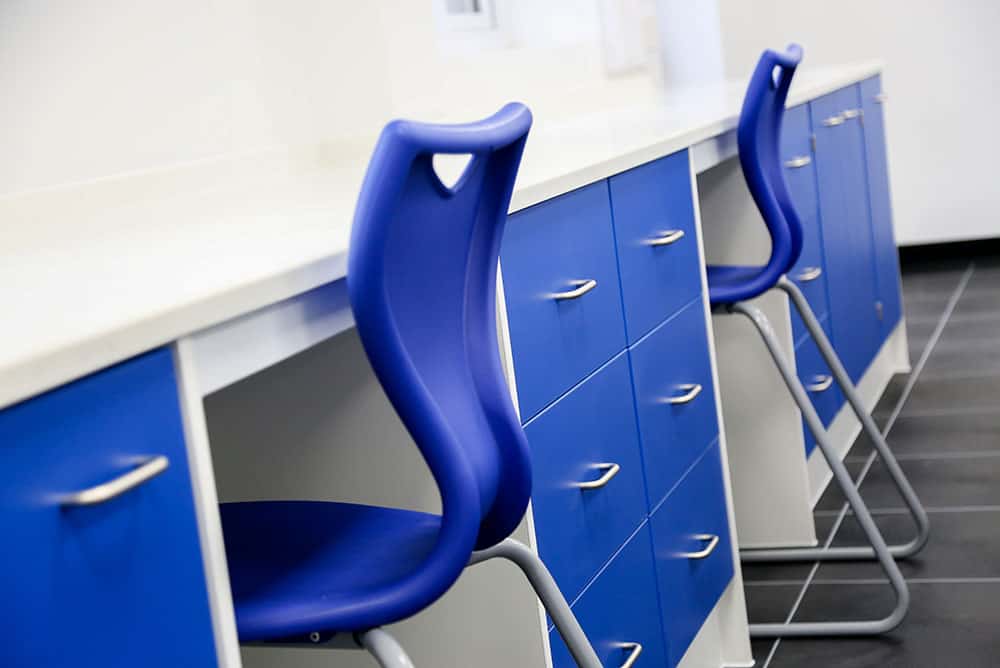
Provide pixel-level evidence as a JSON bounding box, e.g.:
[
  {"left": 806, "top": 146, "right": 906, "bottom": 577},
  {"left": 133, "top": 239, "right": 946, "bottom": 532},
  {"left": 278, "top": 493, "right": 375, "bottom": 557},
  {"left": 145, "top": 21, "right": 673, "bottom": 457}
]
[{"left": 729, "top": 303, "right": 910, "bottom": 638}]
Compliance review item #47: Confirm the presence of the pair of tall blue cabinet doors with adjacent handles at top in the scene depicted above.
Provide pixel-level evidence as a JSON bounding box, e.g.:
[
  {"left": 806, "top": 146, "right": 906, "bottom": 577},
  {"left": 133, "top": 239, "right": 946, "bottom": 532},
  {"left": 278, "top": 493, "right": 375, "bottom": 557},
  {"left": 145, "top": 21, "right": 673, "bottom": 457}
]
[{"left": 809, "top": 86, "right": 881, "bottom": 382}]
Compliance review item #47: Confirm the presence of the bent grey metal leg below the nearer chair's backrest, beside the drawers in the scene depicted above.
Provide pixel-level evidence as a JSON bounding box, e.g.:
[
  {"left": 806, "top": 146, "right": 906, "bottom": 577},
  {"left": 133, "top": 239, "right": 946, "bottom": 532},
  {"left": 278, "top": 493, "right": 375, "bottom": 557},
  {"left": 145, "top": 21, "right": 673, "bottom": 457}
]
[{"left": 469, "top": 538, "right": 601, "bottom": 668}]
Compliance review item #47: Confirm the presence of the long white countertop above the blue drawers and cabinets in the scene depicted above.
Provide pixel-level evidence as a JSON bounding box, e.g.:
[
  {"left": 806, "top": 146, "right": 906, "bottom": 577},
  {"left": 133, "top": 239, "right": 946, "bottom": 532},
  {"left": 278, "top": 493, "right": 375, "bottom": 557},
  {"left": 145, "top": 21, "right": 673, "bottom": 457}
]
[{"left": 0, "top": 62, "right": 881, "bottom": 406}]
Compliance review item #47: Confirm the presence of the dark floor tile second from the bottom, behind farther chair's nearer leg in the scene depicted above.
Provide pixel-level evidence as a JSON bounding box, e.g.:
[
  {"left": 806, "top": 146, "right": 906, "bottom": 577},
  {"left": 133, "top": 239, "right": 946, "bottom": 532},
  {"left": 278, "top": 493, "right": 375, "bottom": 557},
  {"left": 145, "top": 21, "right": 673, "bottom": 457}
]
[{"left": 816, "top": 507, "right": 1000, "bottom": 581}]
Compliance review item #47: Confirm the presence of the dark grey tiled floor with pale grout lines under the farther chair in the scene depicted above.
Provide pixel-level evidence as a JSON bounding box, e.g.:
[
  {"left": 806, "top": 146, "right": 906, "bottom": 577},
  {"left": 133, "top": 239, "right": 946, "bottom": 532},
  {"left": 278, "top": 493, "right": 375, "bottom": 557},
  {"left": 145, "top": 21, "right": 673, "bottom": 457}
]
[{"left": 743, "top": 257, "right": 1000, "bottom": 668}]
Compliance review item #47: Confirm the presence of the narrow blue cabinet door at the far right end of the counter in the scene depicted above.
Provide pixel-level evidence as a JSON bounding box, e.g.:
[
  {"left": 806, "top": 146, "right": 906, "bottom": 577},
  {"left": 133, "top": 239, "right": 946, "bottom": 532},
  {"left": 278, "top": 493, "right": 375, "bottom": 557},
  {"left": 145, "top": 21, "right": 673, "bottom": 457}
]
[{"left": 861, "top": 76, "right": 903, "bottom": 340}]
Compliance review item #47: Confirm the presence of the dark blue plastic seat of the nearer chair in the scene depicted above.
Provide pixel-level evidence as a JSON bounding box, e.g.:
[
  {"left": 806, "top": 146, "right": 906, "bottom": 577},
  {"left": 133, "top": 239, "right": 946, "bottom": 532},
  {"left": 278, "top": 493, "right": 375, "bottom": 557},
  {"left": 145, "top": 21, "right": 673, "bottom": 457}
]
[{"left": 220, "top": 501, "right": 441, "bottom": 641}]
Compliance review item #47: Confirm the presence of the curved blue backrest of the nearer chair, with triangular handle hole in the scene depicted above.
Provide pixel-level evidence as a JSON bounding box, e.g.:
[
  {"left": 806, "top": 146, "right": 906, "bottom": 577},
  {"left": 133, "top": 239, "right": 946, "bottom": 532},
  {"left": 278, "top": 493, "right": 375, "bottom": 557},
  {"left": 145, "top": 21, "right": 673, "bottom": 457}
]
[{"left": 347, "top": 103, "right": 531, "bottom": 593}]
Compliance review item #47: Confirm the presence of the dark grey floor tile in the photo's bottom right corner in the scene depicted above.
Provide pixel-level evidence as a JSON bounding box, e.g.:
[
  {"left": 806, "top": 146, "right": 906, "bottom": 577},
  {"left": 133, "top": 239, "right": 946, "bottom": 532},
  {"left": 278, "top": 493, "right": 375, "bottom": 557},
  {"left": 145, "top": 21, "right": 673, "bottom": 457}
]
[{"left": 770, "top": 584, "right": 1000, "bottom": 668}]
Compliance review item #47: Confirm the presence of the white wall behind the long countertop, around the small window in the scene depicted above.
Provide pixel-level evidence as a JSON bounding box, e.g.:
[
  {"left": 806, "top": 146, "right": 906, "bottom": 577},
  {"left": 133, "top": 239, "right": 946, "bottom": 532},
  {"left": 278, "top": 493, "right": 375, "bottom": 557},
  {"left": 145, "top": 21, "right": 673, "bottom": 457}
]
[{"left": 0, "top": 0, "right": 604, "bottom": 196}]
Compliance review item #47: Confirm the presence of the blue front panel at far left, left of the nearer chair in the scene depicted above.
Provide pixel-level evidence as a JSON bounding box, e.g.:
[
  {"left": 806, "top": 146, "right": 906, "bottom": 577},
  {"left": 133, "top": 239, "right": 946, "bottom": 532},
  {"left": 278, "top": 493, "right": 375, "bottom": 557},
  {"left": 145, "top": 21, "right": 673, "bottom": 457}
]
[{"left": 0, "top": 350, "right": 215, "bottom": 668}]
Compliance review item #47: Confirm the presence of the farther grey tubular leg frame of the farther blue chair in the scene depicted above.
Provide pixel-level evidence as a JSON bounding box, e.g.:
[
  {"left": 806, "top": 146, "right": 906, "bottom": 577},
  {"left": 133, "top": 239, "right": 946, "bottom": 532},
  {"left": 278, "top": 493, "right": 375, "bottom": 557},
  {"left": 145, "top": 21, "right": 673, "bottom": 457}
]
[{"left": 740, "top": 276, "right": 930, "bottom": 562}]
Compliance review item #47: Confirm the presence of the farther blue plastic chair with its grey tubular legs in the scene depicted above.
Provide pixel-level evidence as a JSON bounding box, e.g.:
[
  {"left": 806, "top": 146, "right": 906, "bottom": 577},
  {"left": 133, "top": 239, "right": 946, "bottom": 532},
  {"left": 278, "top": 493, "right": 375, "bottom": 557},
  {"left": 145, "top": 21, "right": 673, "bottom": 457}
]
[{"left": 707, "top": 45, "right": 928, "bottom": 637}]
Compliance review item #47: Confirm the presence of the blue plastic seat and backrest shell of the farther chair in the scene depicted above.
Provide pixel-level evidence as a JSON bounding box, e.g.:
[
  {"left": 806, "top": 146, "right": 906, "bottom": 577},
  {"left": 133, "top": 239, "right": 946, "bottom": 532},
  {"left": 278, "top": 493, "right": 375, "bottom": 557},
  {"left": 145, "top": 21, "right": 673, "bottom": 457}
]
[{"left": 708, "top": 44, "right": 802, "bottom": 304}]
